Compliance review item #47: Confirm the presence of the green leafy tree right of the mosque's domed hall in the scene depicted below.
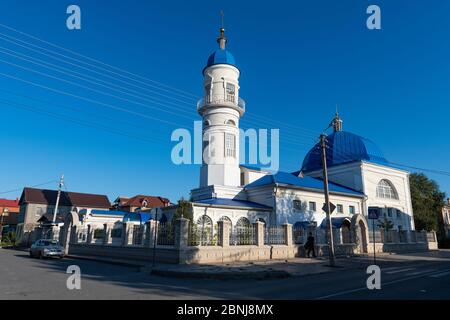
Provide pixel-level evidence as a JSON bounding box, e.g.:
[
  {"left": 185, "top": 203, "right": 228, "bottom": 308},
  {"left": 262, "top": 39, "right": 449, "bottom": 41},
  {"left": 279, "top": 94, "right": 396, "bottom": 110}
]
[{"left": 409, "top": 173, "right": 445, "bottom": 231}]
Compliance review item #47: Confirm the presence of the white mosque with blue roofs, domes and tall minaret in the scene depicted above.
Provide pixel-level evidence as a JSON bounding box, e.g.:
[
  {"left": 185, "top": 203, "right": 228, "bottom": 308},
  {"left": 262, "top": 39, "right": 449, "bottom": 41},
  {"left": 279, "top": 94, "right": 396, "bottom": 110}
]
[{"left": 166, "top": 28, "right": 414, "bottom": 235}]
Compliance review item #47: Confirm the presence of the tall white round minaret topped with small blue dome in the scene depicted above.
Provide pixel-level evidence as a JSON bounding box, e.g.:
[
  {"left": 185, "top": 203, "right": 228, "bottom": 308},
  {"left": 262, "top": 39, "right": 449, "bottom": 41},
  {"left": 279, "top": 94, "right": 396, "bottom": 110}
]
[{"left": 197, "top": 25, "right": 245, "bottom": 188}]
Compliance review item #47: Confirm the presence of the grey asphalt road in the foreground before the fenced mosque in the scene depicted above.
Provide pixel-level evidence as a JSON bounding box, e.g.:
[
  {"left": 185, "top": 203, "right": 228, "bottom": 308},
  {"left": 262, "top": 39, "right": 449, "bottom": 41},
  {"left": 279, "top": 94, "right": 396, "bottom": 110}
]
[{"left": 0, "top": 249, "right": 450, "bottom": 300}]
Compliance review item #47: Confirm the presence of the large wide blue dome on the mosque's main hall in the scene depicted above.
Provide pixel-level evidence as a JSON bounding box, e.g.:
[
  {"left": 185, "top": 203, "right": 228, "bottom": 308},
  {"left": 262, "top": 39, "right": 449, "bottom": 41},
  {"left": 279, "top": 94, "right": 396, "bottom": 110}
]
[{"left": 302, "top": 131, "right": 388, "bottom": 172}]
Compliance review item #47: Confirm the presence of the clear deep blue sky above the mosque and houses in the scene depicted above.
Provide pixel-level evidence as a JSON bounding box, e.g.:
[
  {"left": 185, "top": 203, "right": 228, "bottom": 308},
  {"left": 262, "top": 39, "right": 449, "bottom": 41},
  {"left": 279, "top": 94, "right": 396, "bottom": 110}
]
[{"left": 0, "top": 0, "right": 450, "bottom": 201}]
